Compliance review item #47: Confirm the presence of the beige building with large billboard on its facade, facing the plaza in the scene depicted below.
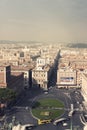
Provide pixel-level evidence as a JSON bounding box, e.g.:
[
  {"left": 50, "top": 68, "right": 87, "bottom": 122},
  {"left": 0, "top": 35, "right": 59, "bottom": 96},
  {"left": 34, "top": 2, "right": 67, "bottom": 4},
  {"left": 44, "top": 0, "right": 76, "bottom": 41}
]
[{"left": 57, "top": 68, "right": 77, "bottom": 88}]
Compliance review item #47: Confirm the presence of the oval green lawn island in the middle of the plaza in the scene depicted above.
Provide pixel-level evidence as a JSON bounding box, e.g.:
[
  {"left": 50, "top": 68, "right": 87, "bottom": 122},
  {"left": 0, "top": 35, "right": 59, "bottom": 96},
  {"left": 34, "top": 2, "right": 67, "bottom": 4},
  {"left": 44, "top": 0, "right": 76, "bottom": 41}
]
[{"left": 32, "top": 98, "right": 64, "bottom": 120}]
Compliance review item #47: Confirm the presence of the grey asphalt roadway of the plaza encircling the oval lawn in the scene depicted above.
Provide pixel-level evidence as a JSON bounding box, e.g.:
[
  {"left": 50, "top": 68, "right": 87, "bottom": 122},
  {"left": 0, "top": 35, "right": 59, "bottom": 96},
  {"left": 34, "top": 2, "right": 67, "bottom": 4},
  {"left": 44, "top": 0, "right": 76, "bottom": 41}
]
[{"left": 3, "top": 88, "right": 83, "bottom": 130}]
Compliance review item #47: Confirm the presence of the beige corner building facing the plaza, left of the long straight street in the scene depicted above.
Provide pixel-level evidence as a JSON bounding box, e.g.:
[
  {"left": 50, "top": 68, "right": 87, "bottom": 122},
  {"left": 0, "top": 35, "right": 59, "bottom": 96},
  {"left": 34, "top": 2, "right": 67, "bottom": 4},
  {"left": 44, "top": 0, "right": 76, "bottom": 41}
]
[{"left": 32, "top": 65, "right": 52, "bottom": 89}]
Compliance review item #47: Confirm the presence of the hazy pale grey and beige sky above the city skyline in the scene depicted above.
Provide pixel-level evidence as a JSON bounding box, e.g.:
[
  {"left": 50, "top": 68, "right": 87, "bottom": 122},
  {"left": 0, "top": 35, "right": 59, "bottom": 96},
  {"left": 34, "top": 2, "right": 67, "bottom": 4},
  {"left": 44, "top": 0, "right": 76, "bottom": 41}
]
[{"left": 0, "top": 0, "right": 87, "bottom": 42}]
